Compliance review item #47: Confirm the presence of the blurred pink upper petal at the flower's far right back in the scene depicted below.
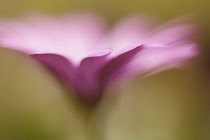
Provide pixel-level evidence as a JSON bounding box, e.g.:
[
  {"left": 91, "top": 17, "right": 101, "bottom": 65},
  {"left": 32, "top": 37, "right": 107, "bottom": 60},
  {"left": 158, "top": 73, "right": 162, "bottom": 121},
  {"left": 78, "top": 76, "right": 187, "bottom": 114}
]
[{"left": 147, "top": 17, "right": 198, "bottom": 47}]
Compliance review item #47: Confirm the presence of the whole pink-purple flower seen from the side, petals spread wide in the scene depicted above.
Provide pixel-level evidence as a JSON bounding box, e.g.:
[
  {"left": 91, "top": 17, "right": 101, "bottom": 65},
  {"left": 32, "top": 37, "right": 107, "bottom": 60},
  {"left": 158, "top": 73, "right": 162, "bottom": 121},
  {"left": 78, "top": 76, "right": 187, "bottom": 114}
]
[{"left": 0, "top": 14, "right": 197, "bottom": 104}]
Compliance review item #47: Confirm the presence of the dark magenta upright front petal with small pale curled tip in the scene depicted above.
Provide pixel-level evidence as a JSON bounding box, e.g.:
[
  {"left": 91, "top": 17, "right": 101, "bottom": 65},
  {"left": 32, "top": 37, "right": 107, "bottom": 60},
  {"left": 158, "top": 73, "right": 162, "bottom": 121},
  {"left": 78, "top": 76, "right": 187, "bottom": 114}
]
[{"left": 74, "top": 50, "right": 111, "bottom": 105}]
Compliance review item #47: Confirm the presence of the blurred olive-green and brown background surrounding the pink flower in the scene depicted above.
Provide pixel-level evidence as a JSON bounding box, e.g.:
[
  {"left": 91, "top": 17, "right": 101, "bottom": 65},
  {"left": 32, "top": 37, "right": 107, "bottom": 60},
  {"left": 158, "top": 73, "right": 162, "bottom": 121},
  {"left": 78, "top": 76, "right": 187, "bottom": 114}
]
[{"left": 0, "top": 0, "right": 210, "bottom": 140}]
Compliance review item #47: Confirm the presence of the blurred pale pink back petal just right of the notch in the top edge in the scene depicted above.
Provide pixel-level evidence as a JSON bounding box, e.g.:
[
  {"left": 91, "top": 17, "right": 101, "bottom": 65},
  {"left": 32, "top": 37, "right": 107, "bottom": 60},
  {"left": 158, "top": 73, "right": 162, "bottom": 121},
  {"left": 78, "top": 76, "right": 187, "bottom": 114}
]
[{"left": 99, "top": 15, "right": 153, "bottom": 56}]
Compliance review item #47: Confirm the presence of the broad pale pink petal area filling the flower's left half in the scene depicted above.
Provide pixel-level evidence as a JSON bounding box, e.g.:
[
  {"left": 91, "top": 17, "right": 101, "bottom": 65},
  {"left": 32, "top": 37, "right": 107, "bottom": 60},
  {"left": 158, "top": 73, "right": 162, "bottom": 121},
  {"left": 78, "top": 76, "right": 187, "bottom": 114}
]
[{"left": 0, "top": 14, "right": 105, "bottom": 64}]
